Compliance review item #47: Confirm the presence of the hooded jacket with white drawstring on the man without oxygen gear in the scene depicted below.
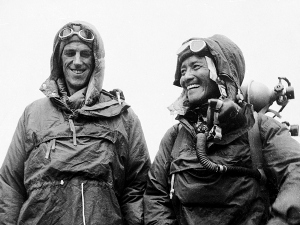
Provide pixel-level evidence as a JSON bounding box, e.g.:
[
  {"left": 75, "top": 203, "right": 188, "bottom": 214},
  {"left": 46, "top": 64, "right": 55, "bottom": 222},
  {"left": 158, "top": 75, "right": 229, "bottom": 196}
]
[{"left": 0, "top": 21, "right": 150, "bottom": 225}]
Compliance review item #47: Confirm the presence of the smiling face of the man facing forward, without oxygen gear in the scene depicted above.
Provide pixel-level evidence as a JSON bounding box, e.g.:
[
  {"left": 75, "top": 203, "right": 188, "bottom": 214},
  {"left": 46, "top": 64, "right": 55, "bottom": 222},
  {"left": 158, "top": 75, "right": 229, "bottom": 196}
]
[{"left": 61, "top": 42, "right": 94, "bottom": 95}]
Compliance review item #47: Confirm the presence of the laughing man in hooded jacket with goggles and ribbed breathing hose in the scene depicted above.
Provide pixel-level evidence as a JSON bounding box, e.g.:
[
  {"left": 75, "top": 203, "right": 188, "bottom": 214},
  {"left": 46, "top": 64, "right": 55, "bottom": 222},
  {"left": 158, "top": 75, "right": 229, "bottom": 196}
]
[{"left": 144, "top": 35, "right": 300, "bottom": 225}]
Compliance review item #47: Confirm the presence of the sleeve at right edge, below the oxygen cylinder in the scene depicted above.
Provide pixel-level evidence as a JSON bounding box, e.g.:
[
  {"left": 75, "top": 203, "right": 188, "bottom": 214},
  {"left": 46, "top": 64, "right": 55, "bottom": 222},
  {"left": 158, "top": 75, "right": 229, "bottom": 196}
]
[{"left": 260, "top": 115, "right": 300, "bottom": 224}]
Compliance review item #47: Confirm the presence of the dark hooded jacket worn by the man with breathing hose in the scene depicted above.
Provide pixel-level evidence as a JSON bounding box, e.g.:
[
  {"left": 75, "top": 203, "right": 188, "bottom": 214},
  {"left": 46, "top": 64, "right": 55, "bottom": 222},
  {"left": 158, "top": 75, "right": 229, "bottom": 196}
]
[{"left": 144, "top": 35, "right": 300, "bottom": 225}]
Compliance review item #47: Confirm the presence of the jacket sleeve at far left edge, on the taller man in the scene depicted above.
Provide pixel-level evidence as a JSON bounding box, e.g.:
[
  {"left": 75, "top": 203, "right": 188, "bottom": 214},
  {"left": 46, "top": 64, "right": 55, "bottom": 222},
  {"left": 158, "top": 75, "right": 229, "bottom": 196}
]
[{"left": 0, "top": 111, "right": 26, "bottom": 225}]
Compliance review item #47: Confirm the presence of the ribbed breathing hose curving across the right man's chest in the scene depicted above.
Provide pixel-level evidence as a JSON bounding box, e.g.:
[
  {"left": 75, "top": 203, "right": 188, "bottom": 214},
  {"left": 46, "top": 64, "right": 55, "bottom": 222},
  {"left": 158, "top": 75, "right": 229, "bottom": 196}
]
[{"left": 196, "top": 133, "right": 261, "bottom": 181}]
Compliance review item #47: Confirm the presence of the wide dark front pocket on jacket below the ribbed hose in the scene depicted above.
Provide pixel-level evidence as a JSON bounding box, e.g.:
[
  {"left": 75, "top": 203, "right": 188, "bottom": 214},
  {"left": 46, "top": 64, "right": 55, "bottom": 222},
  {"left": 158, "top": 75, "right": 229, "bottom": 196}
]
[{"left": 174, "top": 169, "right": 257, "bottom": 207}]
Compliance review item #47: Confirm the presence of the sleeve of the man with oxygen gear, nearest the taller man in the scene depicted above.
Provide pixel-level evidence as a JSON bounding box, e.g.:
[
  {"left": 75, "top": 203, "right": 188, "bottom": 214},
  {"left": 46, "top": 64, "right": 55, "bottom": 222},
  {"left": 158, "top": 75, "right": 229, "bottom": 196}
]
[{"left": 144, "top": 126, "right": 177, "bottom": 225}]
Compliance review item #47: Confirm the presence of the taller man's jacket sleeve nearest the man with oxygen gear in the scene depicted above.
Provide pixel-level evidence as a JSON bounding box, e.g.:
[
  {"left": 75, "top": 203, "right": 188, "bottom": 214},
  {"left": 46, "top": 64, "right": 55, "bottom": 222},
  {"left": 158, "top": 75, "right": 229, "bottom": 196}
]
[{"left": 121, "top": 108, "right": 151, "bottom": 225}]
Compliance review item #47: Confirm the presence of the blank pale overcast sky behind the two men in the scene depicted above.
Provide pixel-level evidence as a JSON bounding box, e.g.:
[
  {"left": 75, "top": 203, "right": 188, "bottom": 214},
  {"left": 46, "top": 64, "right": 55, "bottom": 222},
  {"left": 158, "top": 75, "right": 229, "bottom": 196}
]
[{"left": 0, "top": 0, "right": 300, "bottom": 164}]
